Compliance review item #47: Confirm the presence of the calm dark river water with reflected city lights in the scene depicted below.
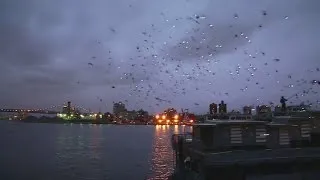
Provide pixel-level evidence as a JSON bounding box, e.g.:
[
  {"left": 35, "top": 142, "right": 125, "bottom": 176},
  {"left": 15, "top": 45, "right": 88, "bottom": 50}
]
[{"left": 0, "top": 121, "right": 190, "bottom": 180}]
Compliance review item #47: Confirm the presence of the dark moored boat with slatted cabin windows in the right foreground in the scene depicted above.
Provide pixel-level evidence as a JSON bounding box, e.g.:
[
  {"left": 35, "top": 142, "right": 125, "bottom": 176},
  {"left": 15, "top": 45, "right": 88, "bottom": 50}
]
[{"left": 171, "top": 117, "right": 320, "bottom": 180}]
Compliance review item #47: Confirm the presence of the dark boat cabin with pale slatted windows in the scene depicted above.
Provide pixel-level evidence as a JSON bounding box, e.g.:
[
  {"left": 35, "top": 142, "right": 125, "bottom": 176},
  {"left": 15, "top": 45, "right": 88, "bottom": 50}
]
[{"left": 192, "top": 120, "right": 301, "bottom": 151}]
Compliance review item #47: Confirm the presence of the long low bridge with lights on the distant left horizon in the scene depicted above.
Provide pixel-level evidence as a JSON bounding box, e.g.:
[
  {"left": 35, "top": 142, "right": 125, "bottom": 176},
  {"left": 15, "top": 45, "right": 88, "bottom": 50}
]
[{"left": 0, "top": 103, "right": 90, "bottom": 114}]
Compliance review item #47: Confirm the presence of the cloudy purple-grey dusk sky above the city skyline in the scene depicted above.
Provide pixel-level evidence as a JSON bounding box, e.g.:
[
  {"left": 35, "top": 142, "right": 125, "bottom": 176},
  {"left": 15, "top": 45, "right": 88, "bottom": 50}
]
[{"left": 0, "top": 0, "right": 320, "bottom": 113}]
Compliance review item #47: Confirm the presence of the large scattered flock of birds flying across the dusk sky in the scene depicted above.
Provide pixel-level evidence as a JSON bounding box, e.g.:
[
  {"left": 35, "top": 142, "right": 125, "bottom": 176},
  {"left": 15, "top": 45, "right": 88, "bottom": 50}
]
[{"left": 84, "top": 11, "right": 320, "bottom": 112}]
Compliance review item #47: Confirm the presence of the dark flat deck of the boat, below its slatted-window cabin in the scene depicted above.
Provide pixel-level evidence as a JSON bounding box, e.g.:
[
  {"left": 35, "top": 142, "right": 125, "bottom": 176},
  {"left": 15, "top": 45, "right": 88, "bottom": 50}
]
[{"left": 176, "top": 146, "right": 320, "bottom": 180}]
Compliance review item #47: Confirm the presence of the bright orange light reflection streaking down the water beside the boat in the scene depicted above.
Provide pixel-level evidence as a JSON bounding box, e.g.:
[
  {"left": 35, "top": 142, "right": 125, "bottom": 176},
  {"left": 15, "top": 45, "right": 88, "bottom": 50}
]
[{"left": 149, "top": 125, "right": 190, "bottom": 180}]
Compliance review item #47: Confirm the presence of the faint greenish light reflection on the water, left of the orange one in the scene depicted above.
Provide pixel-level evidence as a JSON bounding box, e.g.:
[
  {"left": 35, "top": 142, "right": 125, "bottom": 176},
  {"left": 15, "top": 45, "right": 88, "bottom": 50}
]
[{"left": 55, "top": 125, "right": 104, "bottom": 179}]
